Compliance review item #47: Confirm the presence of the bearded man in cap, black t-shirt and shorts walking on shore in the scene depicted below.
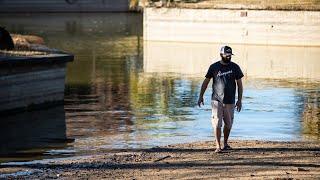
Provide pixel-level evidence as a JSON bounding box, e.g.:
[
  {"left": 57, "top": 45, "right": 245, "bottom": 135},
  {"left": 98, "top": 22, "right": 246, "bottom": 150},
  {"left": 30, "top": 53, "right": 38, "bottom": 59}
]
[{"left": 198, "top": 46, "right": 243, "bottom": 153}]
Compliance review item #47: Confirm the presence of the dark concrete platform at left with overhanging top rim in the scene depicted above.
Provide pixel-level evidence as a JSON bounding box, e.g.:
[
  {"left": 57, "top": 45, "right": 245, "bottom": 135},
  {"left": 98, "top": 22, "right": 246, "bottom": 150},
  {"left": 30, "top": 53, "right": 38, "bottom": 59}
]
[{"left": 0, "top": 55, "right": 73, "bottom": 112}]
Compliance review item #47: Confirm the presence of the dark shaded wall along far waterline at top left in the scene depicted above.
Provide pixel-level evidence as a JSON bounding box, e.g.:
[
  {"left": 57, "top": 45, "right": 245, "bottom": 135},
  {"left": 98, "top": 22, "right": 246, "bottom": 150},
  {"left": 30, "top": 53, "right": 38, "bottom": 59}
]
[{"left": 0, "top": 0, "right": 129, "bottom": 13}]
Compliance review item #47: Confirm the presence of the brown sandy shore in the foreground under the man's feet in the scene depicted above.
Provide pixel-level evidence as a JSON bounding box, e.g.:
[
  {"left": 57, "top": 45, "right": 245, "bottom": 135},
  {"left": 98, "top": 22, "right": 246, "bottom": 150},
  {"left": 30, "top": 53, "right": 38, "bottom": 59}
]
[{"left": 0, "top": 141, "right": 320, "bottom": 179}]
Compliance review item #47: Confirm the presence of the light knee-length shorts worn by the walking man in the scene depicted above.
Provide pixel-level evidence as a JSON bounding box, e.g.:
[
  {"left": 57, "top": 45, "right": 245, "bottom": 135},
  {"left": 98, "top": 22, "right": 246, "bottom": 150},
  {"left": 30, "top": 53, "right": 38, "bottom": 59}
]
[{"left": 211, "top": 100, "right": 235, "bottom": 129}]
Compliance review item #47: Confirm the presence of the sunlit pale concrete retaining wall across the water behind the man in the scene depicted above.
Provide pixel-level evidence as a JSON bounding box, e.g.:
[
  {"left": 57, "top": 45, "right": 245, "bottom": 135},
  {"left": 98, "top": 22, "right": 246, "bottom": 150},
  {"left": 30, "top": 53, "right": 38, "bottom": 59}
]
[{"left": 144, "top": 8, "right": 320, "bottom": 46}]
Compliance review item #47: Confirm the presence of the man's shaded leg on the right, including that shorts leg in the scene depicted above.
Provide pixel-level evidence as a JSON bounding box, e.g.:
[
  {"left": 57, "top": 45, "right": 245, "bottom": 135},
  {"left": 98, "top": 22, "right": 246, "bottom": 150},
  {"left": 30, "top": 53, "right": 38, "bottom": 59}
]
[{"left": 223, "top": 104, "right": 234, "bottom": 147}]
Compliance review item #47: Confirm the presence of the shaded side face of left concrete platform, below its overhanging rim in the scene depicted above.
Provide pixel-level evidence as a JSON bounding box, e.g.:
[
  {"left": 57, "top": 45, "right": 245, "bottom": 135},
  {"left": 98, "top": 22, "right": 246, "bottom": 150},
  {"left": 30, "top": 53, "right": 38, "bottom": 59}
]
[{"left": 0, "top": 65, "right": 66, "bottom": 112}]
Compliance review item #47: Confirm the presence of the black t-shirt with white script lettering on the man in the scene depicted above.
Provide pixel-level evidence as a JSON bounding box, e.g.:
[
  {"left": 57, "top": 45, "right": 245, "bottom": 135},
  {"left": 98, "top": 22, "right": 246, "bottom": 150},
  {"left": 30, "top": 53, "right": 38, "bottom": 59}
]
[{"left": 206, "top": 61, "right": 243, "bottom": 104}]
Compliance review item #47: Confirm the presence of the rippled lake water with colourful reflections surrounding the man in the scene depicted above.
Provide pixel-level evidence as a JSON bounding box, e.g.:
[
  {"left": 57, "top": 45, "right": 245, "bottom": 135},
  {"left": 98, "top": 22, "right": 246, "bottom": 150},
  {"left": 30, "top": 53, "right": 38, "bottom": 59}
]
[{"left": 0, "top": 13, "right": 320, "bottom": 162}]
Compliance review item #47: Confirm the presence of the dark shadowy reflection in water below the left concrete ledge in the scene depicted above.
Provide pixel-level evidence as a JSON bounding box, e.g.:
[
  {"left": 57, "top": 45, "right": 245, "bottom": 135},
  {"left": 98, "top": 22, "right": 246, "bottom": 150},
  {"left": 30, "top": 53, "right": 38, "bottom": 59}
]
[{"left": 0, "top": 106, "right": 72, "bottom": 162}]
